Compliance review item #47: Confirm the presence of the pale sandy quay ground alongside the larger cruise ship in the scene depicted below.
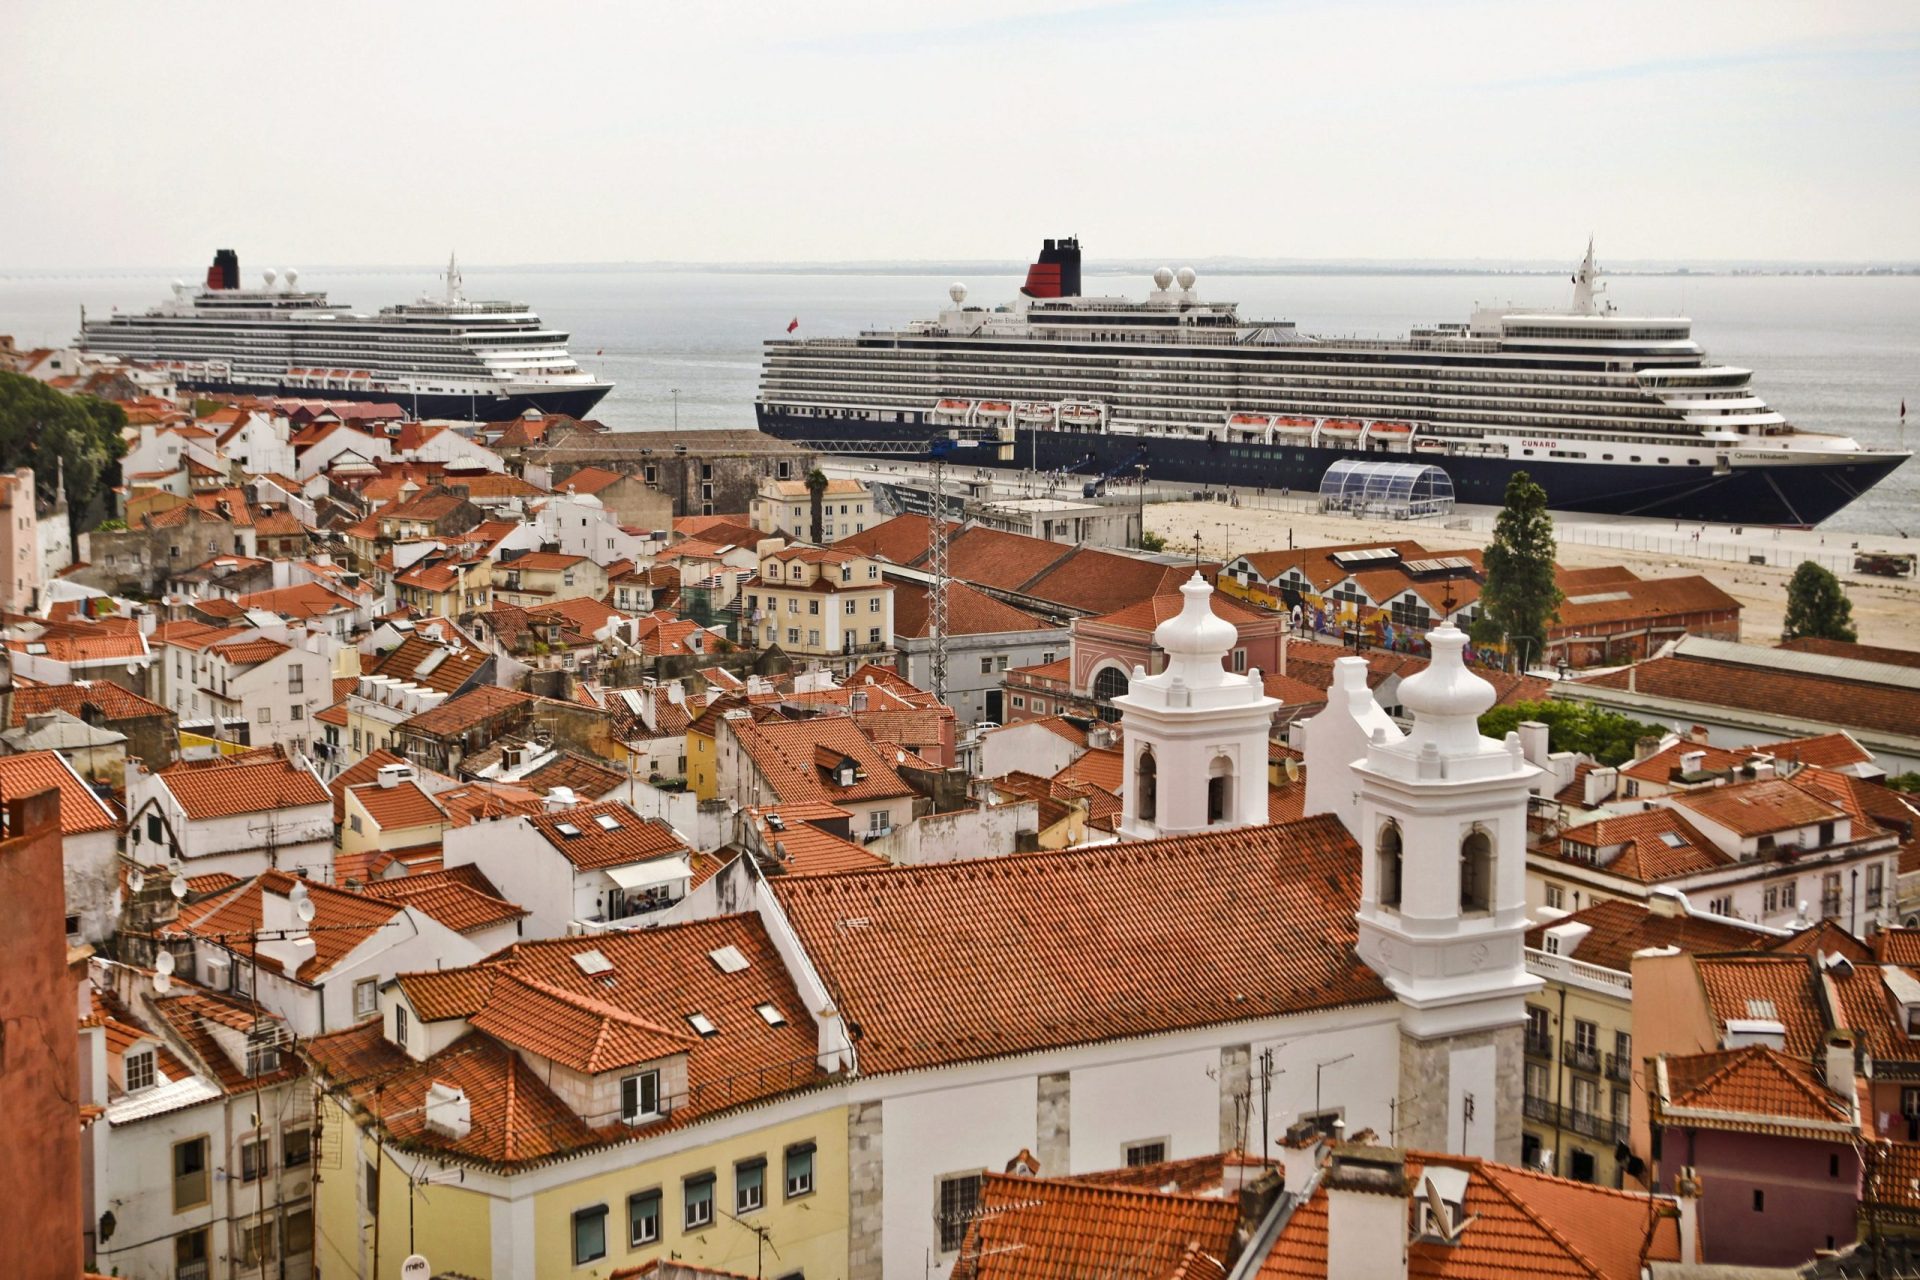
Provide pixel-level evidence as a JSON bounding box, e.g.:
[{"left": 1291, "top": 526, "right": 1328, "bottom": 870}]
[{"left": 1146, "top": 499, "right": 1920, "bottom": 649}]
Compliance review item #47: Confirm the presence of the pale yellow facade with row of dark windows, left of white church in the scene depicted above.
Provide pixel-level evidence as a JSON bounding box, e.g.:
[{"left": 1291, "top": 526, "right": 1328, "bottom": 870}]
[{"left": 313, "top": 1098, "right": 849, "bottom": 1280}]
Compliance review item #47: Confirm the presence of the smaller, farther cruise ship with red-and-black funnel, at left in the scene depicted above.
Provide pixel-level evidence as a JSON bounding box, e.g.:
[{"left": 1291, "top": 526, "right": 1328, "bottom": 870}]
[{"left": 75, "top": 249, "right": 612, "bottom": 422}]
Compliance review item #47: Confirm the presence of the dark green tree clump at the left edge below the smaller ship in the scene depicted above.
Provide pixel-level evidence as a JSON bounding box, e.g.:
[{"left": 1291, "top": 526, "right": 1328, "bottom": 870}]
[{"left": 0, "top": 372, "right": 127, "bottom": 532}]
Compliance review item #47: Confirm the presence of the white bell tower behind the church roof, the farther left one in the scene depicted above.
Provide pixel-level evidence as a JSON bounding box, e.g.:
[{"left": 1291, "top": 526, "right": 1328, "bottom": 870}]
[{"left": 1114, "top": 572, "right": 1279, "bottom": 841}]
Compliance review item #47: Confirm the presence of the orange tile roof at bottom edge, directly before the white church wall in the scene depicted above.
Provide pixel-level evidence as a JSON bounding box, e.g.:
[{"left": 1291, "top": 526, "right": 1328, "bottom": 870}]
[{"left": 952, "top": 1173, "right": 1240, "bottom": 1280}]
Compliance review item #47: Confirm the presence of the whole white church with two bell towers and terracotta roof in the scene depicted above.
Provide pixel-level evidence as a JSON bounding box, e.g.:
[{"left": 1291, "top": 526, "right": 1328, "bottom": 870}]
[{"left": 676, "top": 576, "right": 1532, "bottom": 1280}]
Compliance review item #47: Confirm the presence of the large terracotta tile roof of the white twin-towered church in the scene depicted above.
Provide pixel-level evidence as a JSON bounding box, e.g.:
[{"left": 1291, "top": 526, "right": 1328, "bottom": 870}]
[{"left": 772, "top": 816, "right": 1388, "bottom": 1071}]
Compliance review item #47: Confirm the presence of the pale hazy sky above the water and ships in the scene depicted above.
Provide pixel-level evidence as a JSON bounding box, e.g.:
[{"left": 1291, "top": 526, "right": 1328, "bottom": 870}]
[{"left": 0, "top": 0, "right": 1920, "bottom": 267}]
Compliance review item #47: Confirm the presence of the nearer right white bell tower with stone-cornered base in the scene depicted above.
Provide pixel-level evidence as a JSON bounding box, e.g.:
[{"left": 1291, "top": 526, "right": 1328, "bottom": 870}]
[{"left": 1351, "top": 626, "right": 1540, "bottom": 1161}]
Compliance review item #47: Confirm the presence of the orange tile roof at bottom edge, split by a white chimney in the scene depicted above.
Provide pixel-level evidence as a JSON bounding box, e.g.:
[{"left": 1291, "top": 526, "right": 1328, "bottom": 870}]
[{"left": 1254, "top": 1151, "right": 1680, "bottom": 1280}]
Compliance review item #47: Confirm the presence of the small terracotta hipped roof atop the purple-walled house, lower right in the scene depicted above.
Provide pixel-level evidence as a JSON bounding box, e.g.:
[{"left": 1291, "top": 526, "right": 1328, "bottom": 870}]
[{"left": 1651, "top": 1044, "right": 1860, "bottom": 1142}]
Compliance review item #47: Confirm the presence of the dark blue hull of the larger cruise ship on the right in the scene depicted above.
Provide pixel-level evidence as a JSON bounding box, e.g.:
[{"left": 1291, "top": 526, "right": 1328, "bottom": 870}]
[{"left": 756, "top": 405, "right": 1907, "bottom": 528}]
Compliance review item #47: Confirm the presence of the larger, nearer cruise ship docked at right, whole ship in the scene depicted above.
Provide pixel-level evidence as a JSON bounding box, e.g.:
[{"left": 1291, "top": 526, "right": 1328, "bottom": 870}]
[{"left": 756, "top": 238, "right": 1912, "bottom": 526}]
